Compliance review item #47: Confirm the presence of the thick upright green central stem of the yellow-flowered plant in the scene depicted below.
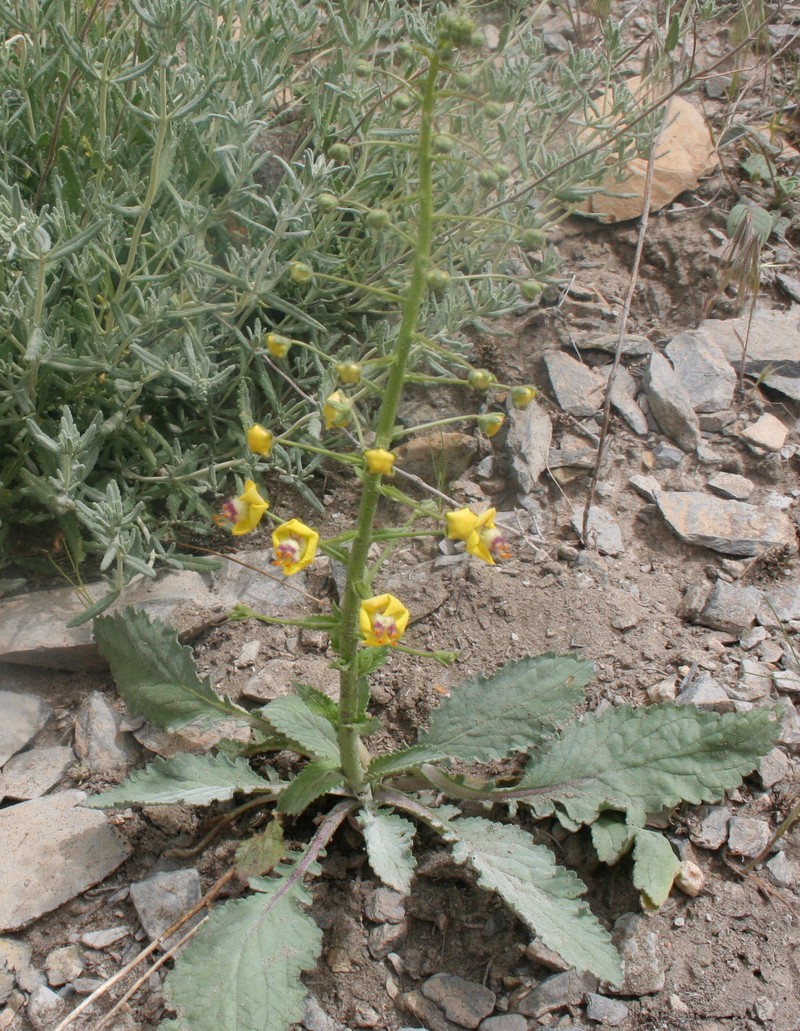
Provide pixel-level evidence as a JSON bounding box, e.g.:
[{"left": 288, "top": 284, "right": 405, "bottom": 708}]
[{"left": 338, "top": 51, "right": 440, "bottom": 794}]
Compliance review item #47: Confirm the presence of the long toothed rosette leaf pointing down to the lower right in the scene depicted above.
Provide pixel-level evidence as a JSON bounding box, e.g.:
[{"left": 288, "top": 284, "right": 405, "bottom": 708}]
[{"left": 448, "top": 818, "right": 622, "bottom": 985}]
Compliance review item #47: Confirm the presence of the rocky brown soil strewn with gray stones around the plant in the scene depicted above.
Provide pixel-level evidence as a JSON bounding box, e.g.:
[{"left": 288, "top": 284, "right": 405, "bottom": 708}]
[{"left": 0, "top": 2, "right": 800, "bottom": 1031}]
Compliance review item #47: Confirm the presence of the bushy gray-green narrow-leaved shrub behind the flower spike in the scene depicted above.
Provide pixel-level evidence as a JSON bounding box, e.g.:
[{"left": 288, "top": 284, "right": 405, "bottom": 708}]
[{"left": 0, "top": 0, "right": 639, "bottom": 585}]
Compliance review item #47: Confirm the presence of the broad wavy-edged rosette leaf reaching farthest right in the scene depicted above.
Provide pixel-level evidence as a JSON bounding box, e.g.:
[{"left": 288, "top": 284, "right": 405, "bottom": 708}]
[{"left": 509, "top": 705, "right": 778, "bottom": 827}]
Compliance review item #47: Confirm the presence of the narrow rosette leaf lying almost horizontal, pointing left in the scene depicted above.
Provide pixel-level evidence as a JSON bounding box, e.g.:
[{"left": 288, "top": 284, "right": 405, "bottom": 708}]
[{"left": 82, "top": 753, "right": 270, "bottom": 809}]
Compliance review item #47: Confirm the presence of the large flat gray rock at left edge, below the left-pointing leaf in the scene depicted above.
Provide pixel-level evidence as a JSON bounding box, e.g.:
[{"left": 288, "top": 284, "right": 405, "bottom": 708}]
[{"left": 0, "top": 791, "right": 131, "bottom": 930}]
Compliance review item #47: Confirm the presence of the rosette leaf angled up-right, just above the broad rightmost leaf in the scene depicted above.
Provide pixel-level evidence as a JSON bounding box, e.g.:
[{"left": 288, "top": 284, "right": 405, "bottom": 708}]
[{"left": 418, "top": 655, "right": 592, "bottom": 762}]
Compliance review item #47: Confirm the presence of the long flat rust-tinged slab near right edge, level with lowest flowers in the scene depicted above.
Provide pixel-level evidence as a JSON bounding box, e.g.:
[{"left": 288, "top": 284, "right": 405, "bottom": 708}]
[{"left": 656, "top": 491, "right": 795, "bottom": 556}]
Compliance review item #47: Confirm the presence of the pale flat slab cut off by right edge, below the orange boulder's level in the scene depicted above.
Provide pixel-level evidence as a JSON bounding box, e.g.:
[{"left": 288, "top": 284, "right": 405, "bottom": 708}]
[{"left": 693, "top": 304, "right": 800, "bottom": 401}]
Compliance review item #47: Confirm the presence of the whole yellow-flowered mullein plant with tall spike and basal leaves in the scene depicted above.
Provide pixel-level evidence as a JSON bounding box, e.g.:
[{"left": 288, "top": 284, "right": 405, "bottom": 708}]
[{"left": 86, "top": 13, "right": 777, "bottom": 1031}]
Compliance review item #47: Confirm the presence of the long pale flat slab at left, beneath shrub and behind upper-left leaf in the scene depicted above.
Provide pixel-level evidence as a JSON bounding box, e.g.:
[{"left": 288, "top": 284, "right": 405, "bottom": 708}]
[{"left": 0, "top": 551, "right": 303, "bottom": 672}]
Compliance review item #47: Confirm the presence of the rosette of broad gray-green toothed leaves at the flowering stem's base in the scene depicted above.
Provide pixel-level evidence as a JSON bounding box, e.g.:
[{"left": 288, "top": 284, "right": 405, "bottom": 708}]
[{"left": 90, "top": 609, "right": 777, "bottom": 1031}]
